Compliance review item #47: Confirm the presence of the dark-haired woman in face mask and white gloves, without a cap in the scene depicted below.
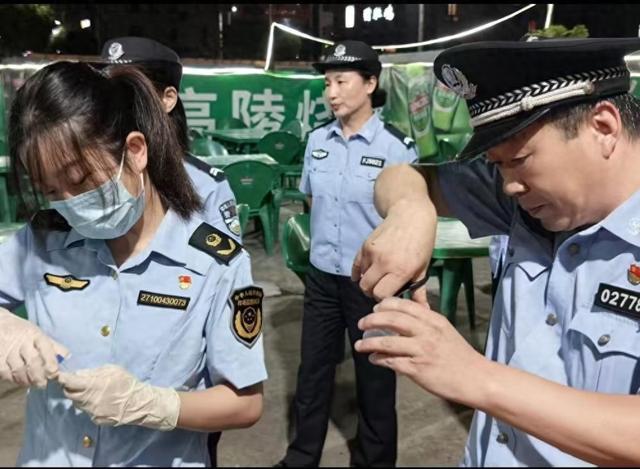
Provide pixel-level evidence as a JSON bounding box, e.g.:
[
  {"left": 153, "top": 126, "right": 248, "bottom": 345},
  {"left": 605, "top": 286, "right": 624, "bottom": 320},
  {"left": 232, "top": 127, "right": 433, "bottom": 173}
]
[{"left": 0, "top": 62, "right": 266, "bottom": 466}]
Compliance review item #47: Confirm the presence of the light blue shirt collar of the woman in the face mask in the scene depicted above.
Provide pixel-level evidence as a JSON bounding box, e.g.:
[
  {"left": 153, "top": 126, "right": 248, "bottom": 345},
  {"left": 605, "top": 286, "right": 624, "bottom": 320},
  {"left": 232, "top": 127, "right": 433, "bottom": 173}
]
[{"left": 64, "top": 209, "right": 208, "bottom": 274}]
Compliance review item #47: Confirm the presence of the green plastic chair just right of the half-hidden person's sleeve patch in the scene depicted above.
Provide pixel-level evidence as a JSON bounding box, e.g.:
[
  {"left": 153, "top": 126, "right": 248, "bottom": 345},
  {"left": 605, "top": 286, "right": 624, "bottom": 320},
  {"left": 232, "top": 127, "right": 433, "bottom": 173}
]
[{"left": 224, "top": 161, "right": 280, "bottom": 255}]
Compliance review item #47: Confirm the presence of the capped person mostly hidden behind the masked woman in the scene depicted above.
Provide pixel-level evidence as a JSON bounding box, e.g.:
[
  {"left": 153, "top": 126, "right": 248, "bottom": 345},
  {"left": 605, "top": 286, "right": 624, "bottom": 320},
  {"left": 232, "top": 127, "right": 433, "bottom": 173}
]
[{"left": 100, "top": 36, "right": 241, "bottom": 245}]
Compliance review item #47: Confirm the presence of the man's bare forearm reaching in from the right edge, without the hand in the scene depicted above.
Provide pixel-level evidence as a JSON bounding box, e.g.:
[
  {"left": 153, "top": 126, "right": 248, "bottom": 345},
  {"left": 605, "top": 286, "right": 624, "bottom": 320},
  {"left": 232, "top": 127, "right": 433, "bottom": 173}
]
[{"left": 472, "top": 362, "right": 640, "bottom": 466}]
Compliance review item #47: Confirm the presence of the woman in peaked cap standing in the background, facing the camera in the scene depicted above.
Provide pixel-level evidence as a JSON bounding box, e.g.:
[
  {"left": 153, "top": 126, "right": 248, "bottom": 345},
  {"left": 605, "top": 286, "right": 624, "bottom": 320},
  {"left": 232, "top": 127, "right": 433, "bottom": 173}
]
[{"left": 280, "top": 41, "right": 417, "bottom": 466}]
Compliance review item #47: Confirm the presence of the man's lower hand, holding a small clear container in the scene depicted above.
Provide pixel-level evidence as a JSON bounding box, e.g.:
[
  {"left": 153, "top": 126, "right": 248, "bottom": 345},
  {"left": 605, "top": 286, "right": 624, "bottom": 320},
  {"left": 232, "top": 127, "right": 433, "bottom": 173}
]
[{"left": 355, "top": 298, "right": 488, "bottom": 405}]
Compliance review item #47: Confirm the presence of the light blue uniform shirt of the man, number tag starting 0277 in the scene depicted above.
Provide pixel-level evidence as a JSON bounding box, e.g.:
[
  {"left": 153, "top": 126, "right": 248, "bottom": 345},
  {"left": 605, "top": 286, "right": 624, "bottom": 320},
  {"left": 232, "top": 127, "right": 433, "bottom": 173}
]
[{"left": 438, "top": 158, "right": 640, "bottom": 466}]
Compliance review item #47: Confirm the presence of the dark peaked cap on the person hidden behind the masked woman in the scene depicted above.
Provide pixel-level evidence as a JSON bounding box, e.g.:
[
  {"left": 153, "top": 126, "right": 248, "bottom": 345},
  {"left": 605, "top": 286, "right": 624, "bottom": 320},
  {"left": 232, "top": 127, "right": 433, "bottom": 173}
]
[{"left": 100, "top": 36, "right": 182, "bottom": 88}]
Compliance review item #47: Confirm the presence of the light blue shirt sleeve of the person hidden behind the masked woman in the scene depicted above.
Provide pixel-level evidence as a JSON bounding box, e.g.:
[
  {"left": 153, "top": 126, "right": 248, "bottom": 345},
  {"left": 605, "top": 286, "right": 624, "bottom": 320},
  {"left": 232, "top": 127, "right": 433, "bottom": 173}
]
[{"left": 184, "top": 159, "right": 242, "bottom": 242}]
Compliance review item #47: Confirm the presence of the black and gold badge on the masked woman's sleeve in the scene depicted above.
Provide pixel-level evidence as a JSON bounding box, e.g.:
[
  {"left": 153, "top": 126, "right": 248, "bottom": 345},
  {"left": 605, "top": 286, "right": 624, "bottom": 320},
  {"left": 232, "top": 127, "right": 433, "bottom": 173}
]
[{"left": 229, "top": 287, "right": 264, "bottom": 348}]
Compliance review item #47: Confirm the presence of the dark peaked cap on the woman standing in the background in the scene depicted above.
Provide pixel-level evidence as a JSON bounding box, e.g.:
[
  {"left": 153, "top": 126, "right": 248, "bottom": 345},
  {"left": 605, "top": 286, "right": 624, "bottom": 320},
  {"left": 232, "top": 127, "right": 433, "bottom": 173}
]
[{"left": 313, "top": 41, "right": 382, "bottom": 77}]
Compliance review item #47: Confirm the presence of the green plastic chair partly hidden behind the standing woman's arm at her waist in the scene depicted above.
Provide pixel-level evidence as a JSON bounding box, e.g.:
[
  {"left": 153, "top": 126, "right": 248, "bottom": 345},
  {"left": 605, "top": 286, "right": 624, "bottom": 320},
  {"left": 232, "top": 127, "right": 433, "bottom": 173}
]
[{"left": 280, "top": 213, "right": 311, "bottom": 283}]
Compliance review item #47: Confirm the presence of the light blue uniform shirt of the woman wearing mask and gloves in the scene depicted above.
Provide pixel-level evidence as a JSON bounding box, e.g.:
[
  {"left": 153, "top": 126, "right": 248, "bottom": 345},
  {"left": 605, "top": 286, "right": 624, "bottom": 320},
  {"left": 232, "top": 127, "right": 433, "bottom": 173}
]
[{"left": 0, "top": 210, "right": 267, "bottom": 466}]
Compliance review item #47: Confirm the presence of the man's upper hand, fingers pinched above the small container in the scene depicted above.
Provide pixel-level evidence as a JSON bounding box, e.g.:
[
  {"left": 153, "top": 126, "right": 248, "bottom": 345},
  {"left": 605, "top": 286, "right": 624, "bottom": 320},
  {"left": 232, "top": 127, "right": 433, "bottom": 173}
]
[{"left": 351, "top": 195, "right": 437, "bottom": 305}]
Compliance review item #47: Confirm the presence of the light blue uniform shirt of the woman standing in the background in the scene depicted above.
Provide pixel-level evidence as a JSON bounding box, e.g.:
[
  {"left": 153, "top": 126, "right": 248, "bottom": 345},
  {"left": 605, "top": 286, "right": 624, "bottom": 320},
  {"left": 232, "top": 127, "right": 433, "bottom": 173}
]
[{"left": 300, "top": 113, "right": 418, "bottom": 276}]
